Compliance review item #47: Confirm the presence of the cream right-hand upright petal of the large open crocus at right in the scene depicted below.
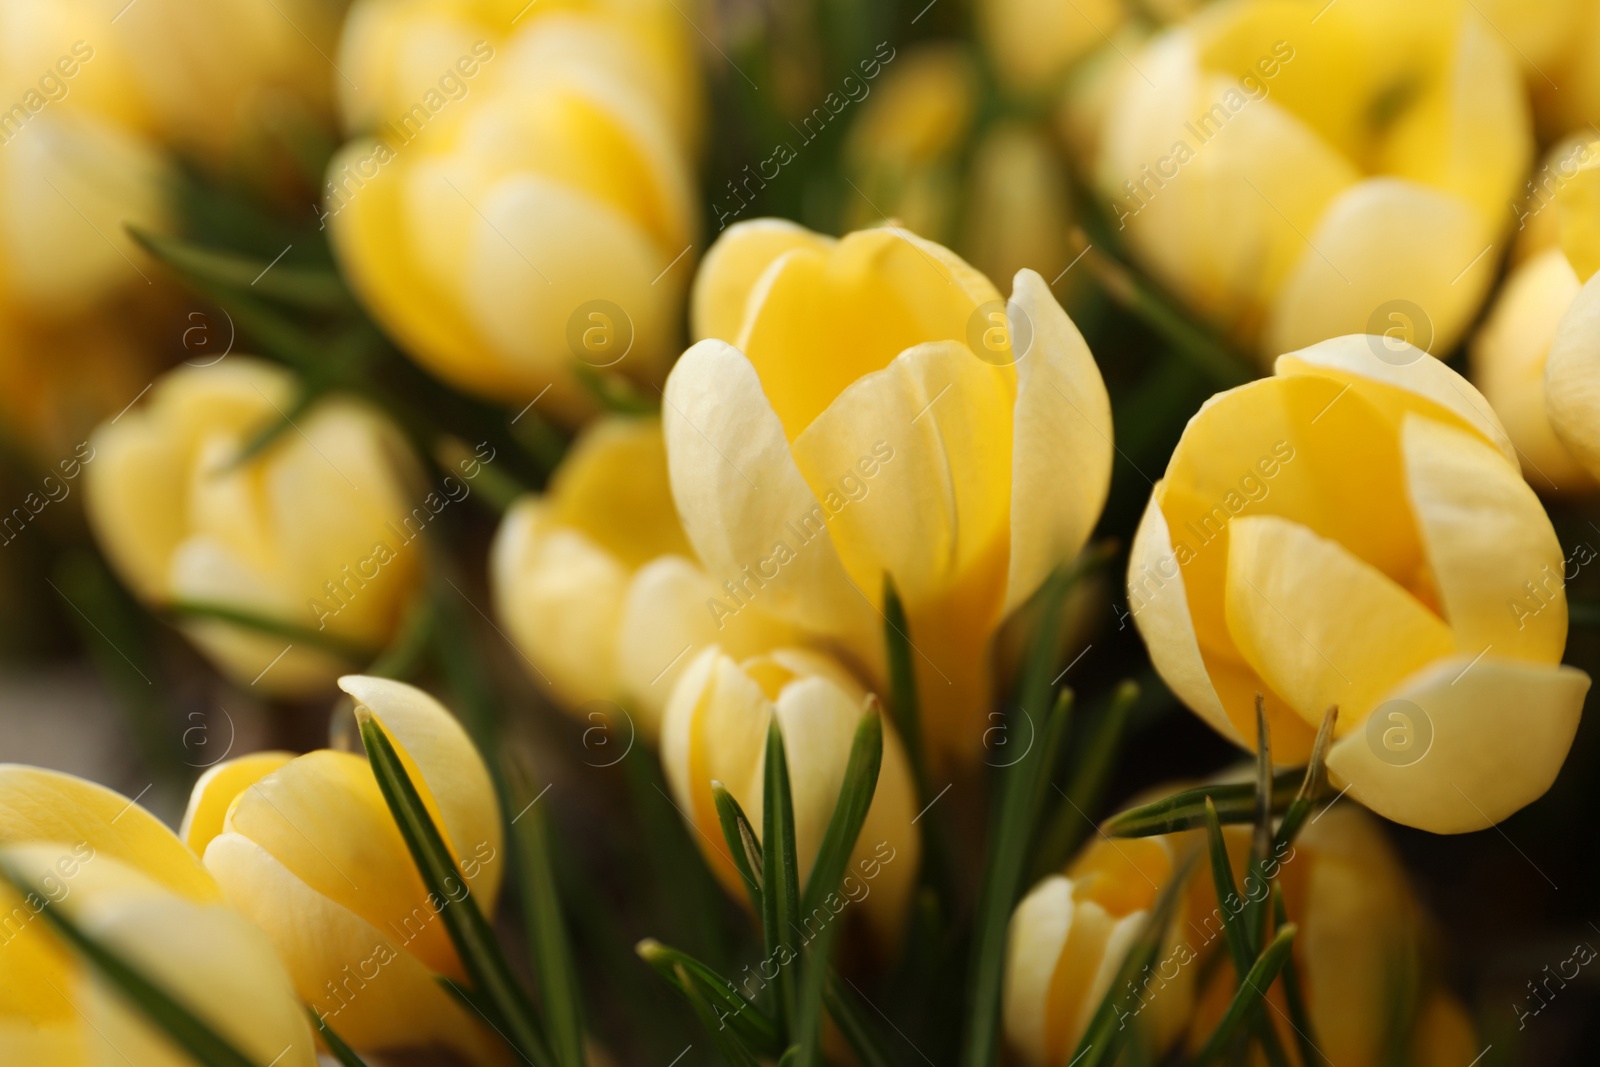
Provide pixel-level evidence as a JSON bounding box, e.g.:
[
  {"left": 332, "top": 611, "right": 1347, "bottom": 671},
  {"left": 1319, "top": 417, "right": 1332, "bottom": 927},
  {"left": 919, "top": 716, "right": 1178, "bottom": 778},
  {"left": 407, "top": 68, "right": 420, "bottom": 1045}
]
[{"left": 1402, "top": 414, "right": 1566, "bottom": 664}]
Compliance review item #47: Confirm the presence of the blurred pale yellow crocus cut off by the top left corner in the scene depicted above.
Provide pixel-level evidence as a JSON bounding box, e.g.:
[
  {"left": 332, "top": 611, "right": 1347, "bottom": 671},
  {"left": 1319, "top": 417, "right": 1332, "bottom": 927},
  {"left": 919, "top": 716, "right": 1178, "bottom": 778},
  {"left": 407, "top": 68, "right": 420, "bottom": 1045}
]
[{"left": 0, "top": 0, "right": 166, "bottom": 317}]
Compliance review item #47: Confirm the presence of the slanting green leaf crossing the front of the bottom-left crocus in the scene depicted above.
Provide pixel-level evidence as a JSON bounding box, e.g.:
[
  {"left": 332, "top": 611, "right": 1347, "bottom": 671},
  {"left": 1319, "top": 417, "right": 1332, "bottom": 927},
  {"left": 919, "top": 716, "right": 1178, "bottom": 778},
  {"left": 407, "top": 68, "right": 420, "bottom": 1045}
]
[{"left": 355, "top": 705, "right": 555, "bottom": 1067}]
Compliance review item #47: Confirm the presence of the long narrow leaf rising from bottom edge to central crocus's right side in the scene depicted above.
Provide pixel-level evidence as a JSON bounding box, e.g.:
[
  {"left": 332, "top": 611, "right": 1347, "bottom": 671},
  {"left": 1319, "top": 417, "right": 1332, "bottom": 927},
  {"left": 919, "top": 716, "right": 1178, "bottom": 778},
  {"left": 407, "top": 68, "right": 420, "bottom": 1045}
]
[{"left": 960, "top": 566, "right": 1078, "bottom": 1067}]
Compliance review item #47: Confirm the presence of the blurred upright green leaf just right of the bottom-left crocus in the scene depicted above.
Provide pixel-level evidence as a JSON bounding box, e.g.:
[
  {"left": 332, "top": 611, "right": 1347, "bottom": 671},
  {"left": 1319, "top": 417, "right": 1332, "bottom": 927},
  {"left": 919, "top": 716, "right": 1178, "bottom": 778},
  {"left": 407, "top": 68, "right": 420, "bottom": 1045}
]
[{"left": 512, "top": 767, "right": 584, "bottom": 1067}]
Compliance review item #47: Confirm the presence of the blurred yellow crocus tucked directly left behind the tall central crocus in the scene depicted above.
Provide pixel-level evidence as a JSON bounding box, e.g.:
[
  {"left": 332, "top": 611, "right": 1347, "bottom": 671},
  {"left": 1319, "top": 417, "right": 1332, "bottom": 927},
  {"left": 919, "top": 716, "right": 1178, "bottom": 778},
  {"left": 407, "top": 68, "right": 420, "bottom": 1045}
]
[{"left": 490, "top": 418, "right": 797, "bottom": 742}]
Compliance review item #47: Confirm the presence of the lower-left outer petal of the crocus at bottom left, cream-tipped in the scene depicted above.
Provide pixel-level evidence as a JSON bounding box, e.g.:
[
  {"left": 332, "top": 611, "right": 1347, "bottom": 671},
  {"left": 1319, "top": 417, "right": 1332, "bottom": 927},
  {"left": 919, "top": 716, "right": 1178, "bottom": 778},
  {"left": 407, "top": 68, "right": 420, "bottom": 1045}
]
[{"left": 205, "top": 833, "right": 509, "bottom": 1065}]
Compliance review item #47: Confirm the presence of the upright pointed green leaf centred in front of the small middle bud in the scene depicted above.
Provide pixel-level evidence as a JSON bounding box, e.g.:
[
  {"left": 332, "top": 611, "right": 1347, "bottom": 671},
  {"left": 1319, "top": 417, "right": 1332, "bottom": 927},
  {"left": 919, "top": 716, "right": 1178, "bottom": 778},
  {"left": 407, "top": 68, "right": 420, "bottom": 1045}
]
[{"left": 762, "top": 715, "right": 800, "bottom": 1033}]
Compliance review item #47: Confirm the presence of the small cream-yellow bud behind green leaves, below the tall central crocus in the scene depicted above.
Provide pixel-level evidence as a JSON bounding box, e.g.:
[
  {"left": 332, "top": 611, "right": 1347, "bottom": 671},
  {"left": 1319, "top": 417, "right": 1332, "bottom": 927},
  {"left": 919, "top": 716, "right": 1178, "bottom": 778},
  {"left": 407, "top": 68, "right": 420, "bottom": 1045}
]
[{"left": 661, "top": 648, "right": 922, "bottom": 947}]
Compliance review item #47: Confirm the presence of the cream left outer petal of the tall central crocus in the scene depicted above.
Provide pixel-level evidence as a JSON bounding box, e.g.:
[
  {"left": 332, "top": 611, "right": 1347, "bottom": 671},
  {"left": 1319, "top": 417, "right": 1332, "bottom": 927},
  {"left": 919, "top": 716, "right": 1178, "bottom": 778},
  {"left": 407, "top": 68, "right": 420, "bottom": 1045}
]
[{"left": 662, "top": 341, "right": 878, "bottom": 649}]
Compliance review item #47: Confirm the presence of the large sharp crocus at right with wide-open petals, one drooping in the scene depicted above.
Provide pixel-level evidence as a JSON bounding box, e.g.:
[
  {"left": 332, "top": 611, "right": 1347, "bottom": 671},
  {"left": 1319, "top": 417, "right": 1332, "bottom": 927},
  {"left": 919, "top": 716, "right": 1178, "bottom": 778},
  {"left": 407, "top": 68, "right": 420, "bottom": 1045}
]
[{"left": 1128, "top": 338, "right": 1589, "bottom": 833}]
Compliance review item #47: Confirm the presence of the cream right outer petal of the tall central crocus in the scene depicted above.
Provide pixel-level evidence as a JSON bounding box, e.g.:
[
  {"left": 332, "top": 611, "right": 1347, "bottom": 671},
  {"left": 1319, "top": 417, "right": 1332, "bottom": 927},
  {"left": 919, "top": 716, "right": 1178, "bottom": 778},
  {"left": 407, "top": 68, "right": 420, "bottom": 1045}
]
[{"left": 1003, "top": 270, "right": 1112, "bottom": 613}]
